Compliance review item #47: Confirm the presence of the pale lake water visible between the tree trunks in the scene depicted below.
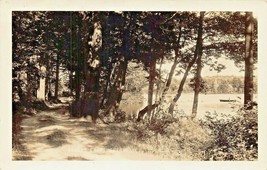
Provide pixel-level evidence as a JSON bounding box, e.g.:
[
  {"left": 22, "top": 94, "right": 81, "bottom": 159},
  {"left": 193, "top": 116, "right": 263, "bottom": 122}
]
[{"left": 120, "top": 93, "right": 257, "bottom": 119}]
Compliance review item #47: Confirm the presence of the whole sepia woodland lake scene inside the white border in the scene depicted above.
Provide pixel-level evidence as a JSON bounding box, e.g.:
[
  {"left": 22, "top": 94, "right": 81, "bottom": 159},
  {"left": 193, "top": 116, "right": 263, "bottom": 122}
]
[{"left": 12, "top": 11, "right": 258, "bottom": 161}]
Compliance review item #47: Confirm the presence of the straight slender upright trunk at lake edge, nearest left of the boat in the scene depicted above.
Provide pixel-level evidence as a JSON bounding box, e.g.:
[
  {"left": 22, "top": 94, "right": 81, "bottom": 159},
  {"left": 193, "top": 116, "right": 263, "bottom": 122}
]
[{"left": 192, "top": 12, "right": 205, "bottom": 118}]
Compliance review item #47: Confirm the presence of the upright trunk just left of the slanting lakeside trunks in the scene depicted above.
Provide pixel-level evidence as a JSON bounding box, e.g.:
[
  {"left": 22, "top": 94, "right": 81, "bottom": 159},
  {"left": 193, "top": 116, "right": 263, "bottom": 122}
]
[{"left": 147, "top": 59, "right": 156, "bottom": 121}]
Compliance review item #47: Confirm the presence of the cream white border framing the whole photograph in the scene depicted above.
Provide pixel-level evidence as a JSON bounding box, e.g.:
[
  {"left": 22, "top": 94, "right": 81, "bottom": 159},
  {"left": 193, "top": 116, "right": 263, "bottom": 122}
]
[{"left": 0, "top": 0, "right": 267, "bottom": 170}]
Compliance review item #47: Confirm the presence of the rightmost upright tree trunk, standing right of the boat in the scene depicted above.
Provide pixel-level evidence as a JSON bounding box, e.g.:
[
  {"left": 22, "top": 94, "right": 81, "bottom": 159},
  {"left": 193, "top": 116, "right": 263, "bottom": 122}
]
[{"left": 244, "top": 12, "right": 254, "bottom": 110}]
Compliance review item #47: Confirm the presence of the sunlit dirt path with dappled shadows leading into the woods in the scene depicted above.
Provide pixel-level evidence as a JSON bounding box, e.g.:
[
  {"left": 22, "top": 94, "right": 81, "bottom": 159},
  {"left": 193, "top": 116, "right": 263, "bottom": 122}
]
[{"left": 14, "top": 102, "right": 163, "bottom": 160}]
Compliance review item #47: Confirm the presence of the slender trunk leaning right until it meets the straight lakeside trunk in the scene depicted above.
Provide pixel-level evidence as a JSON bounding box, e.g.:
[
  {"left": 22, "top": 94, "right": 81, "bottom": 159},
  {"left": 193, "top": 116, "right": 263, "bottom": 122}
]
[{"left": 169, "top": 11, "right": 204, "bottom": 116}]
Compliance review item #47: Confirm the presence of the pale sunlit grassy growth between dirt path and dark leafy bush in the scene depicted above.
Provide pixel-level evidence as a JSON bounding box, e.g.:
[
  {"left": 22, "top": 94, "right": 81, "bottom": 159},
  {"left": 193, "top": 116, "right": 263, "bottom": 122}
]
[{"left": 125, "top": 116, "right": 212, "bottom": 160}]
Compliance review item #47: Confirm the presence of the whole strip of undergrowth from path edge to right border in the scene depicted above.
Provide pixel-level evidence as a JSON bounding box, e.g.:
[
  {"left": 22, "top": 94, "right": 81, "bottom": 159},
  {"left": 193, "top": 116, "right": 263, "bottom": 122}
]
[{"left": 123, "top": 105, "right": 258, "bottom": 161}]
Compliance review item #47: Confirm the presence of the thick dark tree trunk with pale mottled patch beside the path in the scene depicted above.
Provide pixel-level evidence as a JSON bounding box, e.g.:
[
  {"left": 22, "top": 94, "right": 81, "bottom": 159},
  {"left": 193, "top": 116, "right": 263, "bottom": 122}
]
[{"left": 72, "top": 12, "right": 102, "bottom": 122}]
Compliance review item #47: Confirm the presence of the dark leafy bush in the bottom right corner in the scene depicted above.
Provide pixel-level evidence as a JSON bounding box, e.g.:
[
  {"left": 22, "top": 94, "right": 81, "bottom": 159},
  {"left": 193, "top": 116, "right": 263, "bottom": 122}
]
[{"left": 202, "top": 108, "right": 258, "bottom": 160}]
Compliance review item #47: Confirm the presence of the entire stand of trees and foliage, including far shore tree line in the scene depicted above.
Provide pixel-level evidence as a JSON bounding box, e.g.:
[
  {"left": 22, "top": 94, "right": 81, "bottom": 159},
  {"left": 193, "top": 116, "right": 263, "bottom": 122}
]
[{"left": 12, "top": 11, "right": 257, "bottom": 120}]
